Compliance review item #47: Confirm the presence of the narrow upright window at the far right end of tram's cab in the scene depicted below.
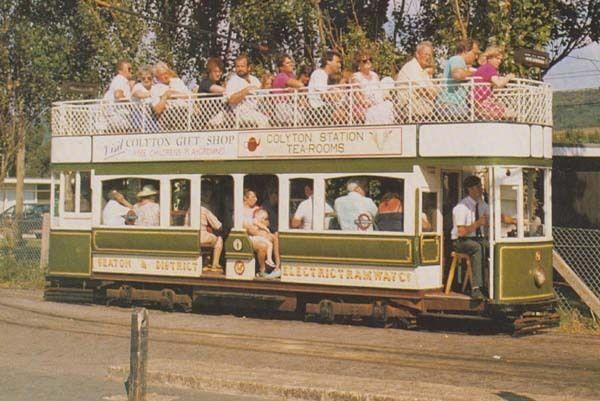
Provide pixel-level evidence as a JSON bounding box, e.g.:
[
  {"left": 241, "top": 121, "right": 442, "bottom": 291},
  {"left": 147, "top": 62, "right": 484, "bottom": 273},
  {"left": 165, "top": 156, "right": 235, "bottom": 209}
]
[{"left": 523, "top": 168, "right": 545, "bottom": 237}]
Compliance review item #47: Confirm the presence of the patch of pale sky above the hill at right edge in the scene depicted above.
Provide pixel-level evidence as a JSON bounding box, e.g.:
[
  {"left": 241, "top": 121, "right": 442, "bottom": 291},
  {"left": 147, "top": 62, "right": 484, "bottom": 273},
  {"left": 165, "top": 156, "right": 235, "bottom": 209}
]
[{"left": 544, "top": 43, "right": 600, "bottom": 90}]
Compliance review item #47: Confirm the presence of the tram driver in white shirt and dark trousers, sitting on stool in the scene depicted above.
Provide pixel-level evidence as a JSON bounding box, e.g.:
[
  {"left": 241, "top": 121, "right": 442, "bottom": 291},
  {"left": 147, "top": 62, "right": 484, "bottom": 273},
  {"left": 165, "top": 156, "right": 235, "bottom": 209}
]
[{"left": 451, "top": 175, "right": 490, "bottom": 299}]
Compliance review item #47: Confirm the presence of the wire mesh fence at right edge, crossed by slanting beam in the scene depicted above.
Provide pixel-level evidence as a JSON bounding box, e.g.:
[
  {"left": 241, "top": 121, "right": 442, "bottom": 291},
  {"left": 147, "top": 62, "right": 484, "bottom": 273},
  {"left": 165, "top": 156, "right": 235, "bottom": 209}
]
[{"left": 552, "top": 227, "right": 600, "bottom": 311}]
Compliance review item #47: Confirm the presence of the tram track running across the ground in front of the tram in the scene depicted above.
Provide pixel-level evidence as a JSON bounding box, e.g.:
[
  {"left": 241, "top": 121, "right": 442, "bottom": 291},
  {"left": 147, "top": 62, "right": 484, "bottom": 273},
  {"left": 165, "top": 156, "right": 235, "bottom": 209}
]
[{"left": 0, "top": 301, "right": 600, "bottom": 386}]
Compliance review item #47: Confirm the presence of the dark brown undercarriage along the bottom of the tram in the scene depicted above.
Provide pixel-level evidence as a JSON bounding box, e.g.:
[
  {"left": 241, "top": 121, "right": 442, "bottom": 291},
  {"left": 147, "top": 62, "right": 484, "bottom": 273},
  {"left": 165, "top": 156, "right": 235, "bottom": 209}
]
[{"left": 44, "top": 277, "right": 559, "bottom": 335}]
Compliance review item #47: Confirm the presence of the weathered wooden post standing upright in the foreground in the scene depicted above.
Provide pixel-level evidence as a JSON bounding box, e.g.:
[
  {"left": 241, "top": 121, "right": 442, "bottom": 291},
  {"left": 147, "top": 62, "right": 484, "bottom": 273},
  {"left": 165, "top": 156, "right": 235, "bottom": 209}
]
[{"left": 125, "top": 308, "right": 148, "bottom": 401}]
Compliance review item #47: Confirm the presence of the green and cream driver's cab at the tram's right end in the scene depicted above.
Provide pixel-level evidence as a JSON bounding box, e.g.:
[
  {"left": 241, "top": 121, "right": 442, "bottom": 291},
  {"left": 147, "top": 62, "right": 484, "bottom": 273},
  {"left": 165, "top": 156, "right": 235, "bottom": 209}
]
[{"left": 434, "top": 166, "right": 552, "bottom": 301}]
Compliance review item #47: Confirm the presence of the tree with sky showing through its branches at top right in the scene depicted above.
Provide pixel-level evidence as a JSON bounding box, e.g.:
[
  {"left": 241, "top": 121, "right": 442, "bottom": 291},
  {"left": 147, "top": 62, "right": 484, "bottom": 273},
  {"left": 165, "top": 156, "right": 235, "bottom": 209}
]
[{"left": 393, "top": 0, "right": 600, "bottom": 76}]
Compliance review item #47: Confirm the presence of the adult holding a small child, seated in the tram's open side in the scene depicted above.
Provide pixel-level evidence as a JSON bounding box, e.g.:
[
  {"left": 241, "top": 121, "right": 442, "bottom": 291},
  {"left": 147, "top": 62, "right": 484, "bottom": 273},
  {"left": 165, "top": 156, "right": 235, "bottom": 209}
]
[{"left": 242, "top": 189, "right": 281, "bottom": 278}]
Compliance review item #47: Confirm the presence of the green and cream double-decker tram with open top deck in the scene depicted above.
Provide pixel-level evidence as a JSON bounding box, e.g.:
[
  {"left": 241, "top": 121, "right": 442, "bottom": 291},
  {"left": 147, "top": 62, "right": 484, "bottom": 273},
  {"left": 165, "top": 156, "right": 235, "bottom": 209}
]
[{"left": 45, "top": 80, "right": 555, "bottom": 331}]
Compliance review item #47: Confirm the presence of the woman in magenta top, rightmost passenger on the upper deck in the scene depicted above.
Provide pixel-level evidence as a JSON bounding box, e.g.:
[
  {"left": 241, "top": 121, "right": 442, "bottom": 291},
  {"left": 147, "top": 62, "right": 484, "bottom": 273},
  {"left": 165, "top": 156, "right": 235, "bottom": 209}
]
[{"left": 473, "top": 46, "right": 515, "bottom": 120}]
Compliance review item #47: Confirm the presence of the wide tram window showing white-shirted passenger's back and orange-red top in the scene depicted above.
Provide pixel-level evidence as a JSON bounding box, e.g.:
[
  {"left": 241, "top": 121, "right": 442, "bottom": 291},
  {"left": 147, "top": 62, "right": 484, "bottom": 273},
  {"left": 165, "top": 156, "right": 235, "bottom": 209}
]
[{"left": 325, "top": 176, "right": 404, "bottom": 232}]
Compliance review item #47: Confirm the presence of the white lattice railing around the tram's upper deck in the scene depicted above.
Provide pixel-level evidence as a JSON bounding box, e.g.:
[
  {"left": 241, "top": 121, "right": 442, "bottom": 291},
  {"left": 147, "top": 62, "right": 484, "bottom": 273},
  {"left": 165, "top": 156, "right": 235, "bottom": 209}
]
[{"left": 52, "top": 79, "right": 552, "bottom": 136}]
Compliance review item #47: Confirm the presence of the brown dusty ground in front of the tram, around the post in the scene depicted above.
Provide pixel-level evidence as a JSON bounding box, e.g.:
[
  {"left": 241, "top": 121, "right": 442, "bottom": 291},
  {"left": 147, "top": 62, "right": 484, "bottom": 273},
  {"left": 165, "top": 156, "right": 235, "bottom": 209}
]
[{"left": 0, "top": 290, "right": 600, "bottom": 401}]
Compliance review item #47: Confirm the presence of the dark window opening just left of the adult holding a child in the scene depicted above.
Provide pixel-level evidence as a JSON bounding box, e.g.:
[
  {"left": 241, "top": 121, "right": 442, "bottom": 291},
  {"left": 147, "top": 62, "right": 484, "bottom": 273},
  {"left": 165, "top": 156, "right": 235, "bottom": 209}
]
[{"left": 200, "top": 175, "right": 233, "bottom": 236}]
